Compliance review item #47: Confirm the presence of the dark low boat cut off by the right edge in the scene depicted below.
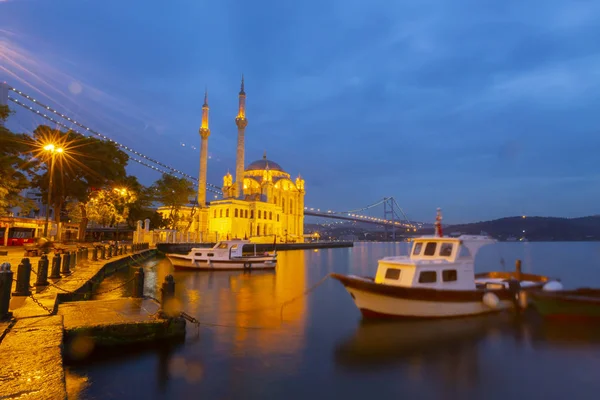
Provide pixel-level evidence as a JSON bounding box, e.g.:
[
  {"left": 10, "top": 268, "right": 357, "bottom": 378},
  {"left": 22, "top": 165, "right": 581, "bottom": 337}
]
[{"left": 530, "top": 288, "right": 600, "bottom": 321}]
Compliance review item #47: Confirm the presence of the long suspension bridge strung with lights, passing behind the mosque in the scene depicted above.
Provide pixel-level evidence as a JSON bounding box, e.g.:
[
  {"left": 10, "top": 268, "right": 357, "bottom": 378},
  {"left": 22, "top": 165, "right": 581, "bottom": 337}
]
[{"left": 0, "top": 82, "right": 417, "bottom": 236}]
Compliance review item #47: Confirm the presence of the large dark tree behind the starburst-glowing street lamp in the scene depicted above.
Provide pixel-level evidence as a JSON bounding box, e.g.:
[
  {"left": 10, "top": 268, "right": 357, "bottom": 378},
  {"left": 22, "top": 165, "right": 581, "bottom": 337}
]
[{"left": 32, "top": 125, "right": 129, "bottom": 240}]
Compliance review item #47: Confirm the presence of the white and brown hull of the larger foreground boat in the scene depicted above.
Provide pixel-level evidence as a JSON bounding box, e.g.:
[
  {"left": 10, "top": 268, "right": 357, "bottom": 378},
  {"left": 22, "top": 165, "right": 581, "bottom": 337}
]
[{"left": 332, "top": 274, "right": 515, "bottom": 319}]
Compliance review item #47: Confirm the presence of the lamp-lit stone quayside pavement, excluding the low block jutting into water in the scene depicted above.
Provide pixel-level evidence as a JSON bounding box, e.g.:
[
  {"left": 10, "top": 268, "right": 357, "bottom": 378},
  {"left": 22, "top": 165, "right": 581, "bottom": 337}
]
[{"left": 0, "top": 248, "right": 159, "bottom": 400}]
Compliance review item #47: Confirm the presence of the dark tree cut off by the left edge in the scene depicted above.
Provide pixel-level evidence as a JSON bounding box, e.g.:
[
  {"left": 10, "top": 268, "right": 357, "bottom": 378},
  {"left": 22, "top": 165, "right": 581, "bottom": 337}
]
[{"left": 0, "top": 105, "right": 35, "bottom": 215}]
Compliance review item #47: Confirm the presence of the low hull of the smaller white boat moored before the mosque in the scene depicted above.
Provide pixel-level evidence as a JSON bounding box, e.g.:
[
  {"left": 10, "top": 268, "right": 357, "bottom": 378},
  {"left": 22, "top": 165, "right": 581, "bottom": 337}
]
[{"left": 167, "top": 254, "right": 277, "bottom": 271}]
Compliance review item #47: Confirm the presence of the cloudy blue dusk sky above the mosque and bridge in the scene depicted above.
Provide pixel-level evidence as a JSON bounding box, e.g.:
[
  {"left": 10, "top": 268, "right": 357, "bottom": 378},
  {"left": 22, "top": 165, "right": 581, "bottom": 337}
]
[{"left": 0, "top": 0, "right": 600, "bottom": 223}]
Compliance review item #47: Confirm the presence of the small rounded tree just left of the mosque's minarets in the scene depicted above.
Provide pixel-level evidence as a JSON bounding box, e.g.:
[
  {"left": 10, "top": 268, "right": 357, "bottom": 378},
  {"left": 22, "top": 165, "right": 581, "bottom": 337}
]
[{"left": 151, "top": 174, "right": 195, "bottom": 229}]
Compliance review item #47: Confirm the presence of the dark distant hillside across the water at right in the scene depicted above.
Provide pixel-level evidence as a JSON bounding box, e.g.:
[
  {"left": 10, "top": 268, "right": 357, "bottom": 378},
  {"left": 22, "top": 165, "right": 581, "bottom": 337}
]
[{"left": 444, "top": 215, "right": 600, "bottom": 241}]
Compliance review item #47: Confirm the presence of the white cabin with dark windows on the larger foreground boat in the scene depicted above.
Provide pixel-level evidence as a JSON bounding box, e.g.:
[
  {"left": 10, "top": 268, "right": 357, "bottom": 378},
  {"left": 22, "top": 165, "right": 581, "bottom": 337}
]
[{"left": 375, "top": 235, "right": 496, "bottom": 290}]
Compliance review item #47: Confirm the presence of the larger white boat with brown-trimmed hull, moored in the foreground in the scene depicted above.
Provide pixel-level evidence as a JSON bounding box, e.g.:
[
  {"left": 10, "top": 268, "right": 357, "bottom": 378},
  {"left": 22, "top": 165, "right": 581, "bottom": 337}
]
[{"left": 331, "top": 209, "right": 550, "bottom": 318}]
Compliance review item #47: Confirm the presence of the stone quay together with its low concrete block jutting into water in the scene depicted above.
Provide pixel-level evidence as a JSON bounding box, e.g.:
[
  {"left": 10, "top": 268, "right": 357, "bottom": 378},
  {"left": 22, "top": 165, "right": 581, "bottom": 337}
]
[{"left": 0, "top": 248, "right": 185, "bottom": 399}]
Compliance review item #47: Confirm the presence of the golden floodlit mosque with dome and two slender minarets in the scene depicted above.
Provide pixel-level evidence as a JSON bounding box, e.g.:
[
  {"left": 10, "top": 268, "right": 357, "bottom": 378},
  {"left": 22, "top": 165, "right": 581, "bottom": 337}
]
[{"left": 159, "top": 76, "right": 305, "bottom": 243}]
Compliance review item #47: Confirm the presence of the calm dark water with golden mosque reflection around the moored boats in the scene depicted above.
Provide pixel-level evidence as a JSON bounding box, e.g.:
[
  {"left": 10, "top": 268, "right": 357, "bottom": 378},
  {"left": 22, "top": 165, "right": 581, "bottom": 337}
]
[{"left": 68, "top": 242, "right": 600, "bottom": 399}]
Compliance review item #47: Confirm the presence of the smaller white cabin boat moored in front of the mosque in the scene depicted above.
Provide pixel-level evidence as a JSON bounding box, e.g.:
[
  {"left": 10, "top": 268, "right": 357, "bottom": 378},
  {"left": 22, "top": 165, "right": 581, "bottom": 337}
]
[{"left": 167, "top": 239, "right": 277, "bottom": 271}]
